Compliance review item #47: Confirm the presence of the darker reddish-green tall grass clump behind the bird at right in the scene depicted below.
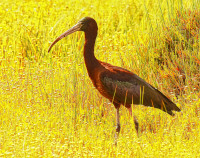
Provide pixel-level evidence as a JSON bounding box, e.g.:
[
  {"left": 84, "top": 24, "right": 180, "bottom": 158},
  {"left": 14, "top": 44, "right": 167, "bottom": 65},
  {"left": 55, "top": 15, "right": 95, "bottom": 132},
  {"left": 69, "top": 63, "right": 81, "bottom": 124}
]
[{"left": 155, "top": 10, "right": 200, "bottom": 95}]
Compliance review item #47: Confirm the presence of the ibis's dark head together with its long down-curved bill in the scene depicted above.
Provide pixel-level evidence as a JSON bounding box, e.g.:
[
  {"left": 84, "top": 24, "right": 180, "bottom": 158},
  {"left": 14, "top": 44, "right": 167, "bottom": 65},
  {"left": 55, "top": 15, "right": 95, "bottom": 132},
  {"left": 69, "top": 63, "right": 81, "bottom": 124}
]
[{"left": 48, "top": 17, "right": 98, "bottom": 52}]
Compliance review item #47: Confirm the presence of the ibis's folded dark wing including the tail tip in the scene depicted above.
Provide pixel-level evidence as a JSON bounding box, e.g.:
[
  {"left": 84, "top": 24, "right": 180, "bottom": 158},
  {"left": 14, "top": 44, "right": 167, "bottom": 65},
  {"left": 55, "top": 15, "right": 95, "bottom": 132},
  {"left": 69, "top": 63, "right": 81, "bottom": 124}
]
[{"left": 100, "top": 67, "right": 180, "bottom": 115}]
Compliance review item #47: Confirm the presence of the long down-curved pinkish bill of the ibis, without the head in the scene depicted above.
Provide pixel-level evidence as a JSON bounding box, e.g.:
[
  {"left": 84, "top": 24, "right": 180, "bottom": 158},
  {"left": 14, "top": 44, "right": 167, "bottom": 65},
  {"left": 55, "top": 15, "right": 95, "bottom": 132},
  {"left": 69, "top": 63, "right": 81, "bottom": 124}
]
[{"left": 48, "top": 23, "right": 82, "bottom": 52}]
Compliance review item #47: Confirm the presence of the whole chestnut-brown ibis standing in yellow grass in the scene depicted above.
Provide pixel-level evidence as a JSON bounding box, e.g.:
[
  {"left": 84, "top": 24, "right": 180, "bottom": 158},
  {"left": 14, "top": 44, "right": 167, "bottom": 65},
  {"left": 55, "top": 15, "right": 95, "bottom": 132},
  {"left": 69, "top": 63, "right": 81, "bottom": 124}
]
[{"left": 48, "top": 17, "right": 181, "bottom": 134}]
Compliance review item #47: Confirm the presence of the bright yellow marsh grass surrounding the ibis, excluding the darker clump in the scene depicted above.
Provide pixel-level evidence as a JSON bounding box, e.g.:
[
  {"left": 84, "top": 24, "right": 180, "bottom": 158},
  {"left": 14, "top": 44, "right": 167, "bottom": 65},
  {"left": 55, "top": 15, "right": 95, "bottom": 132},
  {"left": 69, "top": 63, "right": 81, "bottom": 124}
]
[{"left": 0, "top": 0, "right": 200, "bottom": 158}]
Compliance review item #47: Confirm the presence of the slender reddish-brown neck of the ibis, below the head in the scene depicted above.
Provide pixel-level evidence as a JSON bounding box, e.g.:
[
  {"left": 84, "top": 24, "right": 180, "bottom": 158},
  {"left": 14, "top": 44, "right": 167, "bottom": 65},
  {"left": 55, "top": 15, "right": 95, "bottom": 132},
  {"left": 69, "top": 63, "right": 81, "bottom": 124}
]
[{"left": 84, "top": 33, "right": 100, "bottom": 79}]
